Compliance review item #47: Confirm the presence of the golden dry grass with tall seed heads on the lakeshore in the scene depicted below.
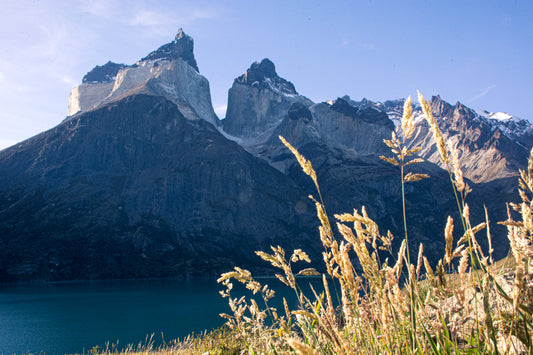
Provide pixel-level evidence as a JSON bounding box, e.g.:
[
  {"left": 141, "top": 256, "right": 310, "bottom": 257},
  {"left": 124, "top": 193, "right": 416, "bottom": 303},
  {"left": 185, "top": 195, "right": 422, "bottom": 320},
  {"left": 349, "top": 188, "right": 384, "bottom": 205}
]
[{"left": 95, "top": 95, "right": 533, "bottom": 354}]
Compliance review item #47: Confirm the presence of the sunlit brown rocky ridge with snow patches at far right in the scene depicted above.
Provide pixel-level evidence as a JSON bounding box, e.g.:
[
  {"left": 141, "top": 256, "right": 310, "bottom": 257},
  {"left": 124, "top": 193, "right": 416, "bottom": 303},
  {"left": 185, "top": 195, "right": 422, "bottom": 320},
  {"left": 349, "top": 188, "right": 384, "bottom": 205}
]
[{"left": 344, "top": 96, "right": 533, "bottom": 183}]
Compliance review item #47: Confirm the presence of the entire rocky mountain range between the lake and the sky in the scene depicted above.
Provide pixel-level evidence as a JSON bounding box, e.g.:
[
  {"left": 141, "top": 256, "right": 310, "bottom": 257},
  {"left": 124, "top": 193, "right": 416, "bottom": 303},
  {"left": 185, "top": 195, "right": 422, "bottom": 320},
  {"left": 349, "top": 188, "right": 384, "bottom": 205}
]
[{"left": 0, "top": 29, "right": 533, "bottom": 282}]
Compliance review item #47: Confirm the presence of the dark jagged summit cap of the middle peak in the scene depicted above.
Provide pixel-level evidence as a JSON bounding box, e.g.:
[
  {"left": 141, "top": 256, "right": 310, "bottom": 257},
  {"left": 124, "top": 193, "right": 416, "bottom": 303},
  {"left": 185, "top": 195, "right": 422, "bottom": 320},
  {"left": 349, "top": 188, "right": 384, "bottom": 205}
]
[{"left": 235, "top": 58, "right": 298, "bottom": 95}]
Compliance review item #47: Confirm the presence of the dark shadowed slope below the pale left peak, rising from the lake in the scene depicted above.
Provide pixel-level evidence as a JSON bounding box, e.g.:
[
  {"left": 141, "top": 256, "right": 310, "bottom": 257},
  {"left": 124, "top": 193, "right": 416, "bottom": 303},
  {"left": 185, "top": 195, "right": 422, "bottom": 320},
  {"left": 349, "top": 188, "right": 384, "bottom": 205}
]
[{"left": 0, "top": 95, "right": 320, "bottom": 281}]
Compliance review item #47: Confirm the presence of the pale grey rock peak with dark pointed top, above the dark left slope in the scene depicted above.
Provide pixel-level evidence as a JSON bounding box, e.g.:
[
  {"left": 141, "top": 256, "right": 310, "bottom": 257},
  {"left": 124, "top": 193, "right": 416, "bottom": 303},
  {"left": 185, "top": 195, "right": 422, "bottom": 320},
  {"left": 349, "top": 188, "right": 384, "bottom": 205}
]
[{"left": 68, "top": 29, "right": 219, "bottom": 125}]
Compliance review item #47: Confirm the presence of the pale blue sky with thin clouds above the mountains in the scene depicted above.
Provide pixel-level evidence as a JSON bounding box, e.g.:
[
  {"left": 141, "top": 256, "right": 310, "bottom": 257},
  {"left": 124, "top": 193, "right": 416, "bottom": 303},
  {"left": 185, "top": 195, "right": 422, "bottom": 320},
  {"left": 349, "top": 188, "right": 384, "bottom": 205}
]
[{"left": 0, "top": 0, "right": 533, "bottom": 148}]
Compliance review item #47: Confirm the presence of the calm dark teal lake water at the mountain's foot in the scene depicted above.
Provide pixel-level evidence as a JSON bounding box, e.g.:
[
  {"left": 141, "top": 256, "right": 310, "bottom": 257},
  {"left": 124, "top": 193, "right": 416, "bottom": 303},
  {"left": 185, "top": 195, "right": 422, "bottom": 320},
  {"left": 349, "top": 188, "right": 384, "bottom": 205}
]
[{"left": 0, "top": 280, "right": 228, "bottom": 355}]
